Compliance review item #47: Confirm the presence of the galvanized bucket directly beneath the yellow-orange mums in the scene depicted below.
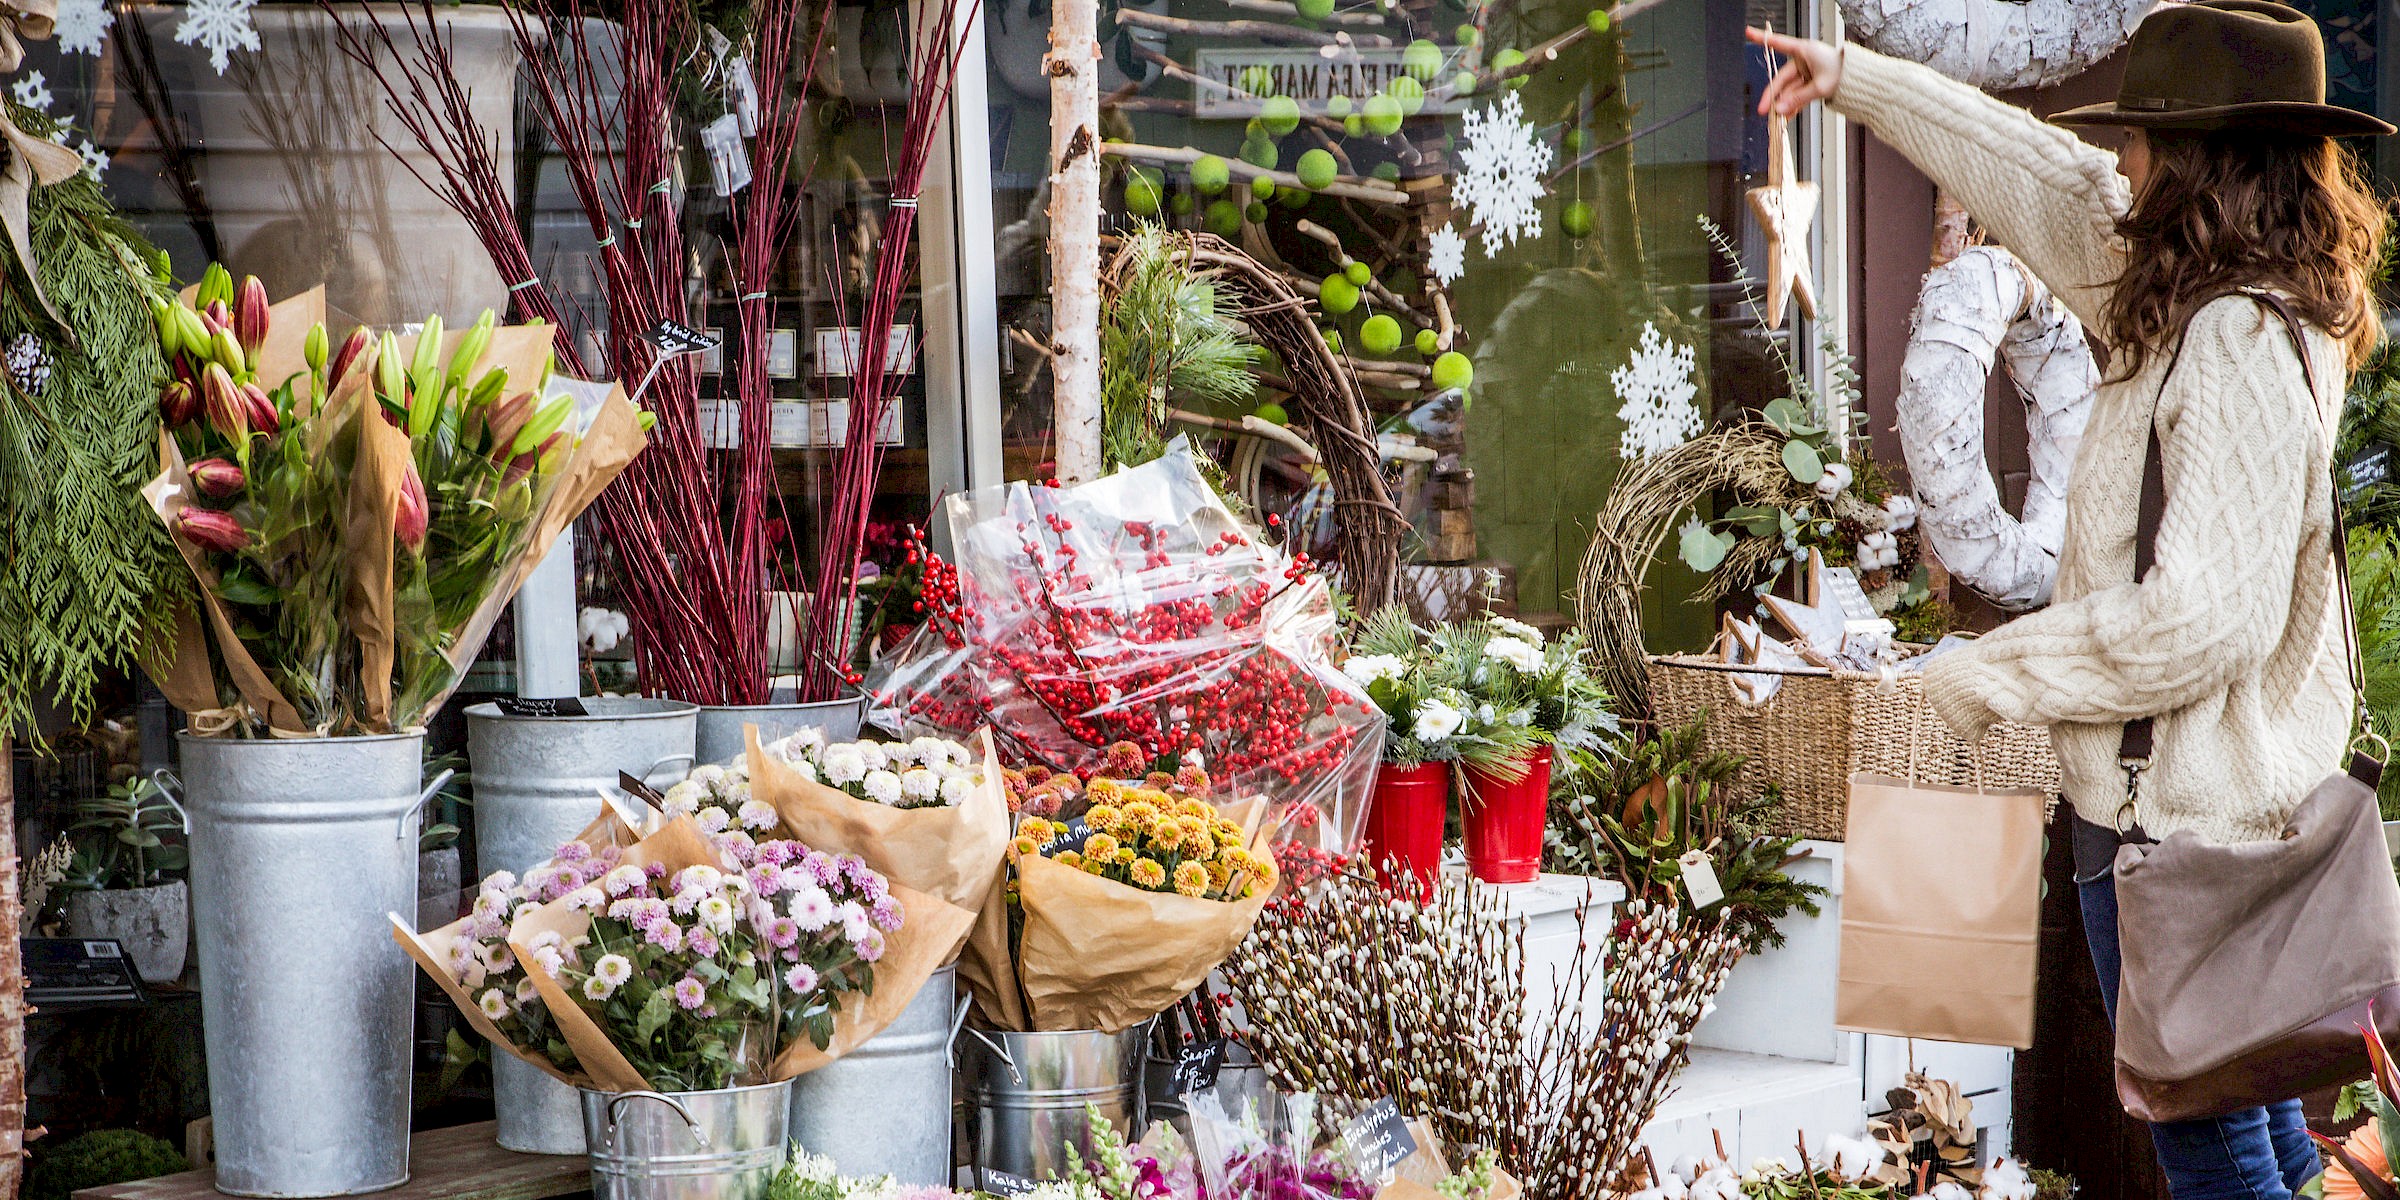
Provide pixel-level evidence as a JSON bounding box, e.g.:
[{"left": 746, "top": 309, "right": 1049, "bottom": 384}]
[{"left": 960, "top": 1022, "right": 1150, "bottom": 1193}]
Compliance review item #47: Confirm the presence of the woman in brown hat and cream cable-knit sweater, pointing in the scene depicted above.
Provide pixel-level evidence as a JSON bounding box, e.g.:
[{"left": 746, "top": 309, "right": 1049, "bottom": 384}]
[{"left": 1750, "top": 9, "right": 2393, "bottom": 1200}]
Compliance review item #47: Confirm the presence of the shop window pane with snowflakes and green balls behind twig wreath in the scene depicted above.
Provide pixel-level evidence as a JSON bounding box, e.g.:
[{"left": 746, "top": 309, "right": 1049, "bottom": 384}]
[{"left": 984, "top": 0, "right": 1812, "bottom": 636}]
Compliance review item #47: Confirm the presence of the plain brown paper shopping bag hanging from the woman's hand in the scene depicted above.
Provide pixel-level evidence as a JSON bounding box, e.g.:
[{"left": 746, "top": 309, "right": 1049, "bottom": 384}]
[{"left": 1834, "top": 775, "right": 2050, "bottom": 1049}]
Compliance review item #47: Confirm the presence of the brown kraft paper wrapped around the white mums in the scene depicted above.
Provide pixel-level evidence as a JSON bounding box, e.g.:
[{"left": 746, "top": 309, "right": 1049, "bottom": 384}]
[{"left": 744, "top": 725, "right": 1008, "bottom": 916}]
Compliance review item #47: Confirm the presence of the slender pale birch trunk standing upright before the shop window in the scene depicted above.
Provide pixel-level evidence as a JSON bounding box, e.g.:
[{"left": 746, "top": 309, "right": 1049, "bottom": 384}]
[{"left": 1044, "top": 0, "right": 1099, "bottom": 485}]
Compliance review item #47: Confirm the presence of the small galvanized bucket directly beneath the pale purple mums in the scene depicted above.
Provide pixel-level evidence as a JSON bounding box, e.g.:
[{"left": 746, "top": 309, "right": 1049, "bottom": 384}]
[{"left": 583, "top": 1080, "right": 792, "bottom": 1200}]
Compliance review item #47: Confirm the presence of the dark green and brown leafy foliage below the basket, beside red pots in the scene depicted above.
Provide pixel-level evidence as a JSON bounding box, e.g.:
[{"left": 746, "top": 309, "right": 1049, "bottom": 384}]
[{"left": 1546, "top": 713, "right": 1826, "bottom": 953}]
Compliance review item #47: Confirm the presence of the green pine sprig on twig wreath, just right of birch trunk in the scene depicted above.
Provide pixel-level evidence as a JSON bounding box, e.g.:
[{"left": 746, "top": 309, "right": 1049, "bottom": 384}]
[{"left": 1099, "top": 221, "right": 1258, "bottom": 468}]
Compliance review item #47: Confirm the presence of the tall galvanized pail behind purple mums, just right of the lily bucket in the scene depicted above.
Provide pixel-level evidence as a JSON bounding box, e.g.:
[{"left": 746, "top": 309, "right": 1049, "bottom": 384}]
[{"left": 466, "top": 696, "right": 698, "bottom": 1154}]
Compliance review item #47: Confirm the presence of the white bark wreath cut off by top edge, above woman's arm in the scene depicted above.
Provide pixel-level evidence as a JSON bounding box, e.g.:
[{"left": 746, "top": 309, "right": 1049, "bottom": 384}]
[{"left": 1841, "top": 0, "right": 2158, "bottom": 91}]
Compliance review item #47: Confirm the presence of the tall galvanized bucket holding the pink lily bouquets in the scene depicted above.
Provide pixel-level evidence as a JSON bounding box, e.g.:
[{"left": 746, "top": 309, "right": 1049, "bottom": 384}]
[{"left": 178, "top": 734, "right": 446, "bottom": 1198}]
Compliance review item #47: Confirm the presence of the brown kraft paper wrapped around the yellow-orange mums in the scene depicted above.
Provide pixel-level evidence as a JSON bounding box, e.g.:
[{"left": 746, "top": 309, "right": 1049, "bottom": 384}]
[{"left": 998, "top": 826, "right": 1274, "bottom": 1034}]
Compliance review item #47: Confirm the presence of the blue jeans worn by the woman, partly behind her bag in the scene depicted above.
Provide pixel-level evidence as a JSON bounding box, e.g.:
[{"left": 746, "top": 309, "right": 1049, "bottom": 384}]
[{"left": 2076, "top": 854, "right": 2321, "bottom": 1200}]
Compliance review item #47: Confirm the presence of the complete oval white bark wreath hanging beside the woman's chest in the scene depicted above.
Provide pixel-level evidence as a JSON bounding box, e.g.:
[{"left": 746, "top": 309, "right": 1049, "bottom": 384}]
[{"left": 1896, "top": 245, "right": 2100, "bottom": 610}]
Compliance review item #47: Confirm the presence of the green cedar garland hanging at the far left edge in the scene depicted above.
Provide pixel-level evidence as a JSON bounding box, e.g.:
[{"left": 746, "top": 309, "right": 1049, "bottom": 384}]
[{"left": 0, "top": 106, "right": 190, "bottom": 727}]
